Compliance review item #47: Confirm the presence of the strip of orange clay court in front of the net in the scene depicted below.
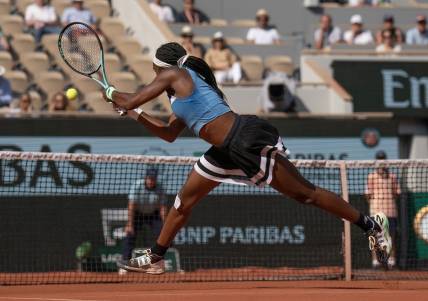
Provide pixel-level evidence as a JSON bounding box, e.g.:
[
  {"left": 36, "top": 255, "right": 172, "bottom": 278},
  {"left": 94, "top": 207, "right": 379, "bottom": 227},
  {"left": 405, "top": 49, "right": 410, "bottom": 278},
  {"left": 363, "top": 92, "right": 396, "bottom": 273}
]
[{"left": 0, "top": 281, "right": 428, "bottom": 301}]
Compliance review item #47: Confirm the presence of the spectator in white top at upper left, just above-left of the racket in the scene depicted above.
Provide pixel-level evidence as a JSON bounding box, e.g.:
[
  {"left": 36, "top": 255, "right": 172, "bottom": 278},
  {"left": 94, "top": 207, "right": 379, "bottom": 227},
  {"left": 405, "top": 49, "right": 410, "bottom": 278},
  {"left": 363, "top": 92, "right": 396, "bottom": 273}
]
[{"left": 25, "top": 0, "right": 61, "bottom": 43}]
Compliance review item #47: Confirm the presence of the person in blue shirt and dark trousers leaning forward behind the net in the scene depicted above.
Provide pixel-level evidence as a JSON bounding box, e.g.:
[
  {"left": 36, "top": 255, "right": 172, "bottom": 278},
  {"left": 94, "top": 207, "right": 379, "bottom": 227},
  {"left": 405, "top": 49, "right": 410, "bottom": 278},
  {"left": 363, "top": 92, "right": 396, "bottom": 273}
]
[{"left": 119, "top": 168, "right": 167, "bottom": 274}]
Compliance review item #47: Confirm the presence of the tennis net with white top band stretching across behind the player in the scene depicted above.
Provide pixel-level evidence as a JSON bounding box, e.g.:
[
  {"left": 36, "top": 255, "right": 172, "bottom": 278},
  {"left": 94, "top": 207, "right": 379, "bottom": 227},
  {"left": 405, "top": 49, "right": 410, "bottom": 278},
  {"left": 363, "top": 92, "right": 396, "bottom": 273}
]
[{"left": 0, "top": 152, "right": 428, "bottom": 285}]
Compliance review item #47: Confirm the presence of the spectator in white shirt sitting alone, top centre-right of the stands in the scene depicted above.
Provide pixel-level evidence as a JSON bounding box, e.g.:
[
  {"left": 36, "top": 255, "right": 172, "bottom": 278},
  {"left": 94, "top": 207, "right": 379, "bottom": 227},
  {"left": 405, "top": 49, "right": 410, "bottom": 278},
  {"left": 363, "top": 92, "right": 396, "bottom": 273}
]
[{"left": 247, "top": 8, "right": 280, "bottom": 45}]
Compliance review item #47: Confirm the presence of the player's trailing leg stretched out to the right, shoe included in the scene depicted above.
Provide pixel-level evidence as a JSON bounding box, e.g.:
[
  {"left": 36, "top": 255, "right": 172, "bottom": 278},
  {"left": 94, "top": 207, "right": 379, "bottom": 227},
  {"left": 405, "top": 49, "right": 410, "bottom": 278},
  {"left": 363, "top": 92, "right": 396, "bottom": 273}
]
[{"left": 270, "top": 154, "right": 391, "bottom": 265}]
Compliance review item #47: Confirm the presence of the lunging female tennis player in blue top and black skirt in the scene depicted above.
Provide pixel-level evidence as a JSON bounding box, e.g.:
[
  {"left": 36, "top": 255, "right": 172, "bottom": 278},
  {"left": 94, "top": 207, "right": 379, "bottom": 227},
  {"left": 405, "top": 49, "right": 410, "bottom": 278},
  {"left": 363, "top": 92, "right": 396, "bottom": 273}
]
[{"left": 104, "top": 43, "right": 391, "bottom": 272}]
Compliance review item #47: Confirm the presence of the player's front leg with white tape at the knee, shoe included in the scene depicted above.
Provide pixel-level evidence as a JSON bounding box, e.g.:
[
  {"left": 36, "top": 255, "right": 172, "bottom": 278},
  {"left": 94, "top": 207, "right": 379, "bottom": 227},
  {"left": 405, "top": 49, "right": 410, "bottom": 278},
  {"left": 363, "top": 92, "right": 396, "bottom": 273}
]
[{"left": 118, "top": 169, "right": 220, "bottom": 271}]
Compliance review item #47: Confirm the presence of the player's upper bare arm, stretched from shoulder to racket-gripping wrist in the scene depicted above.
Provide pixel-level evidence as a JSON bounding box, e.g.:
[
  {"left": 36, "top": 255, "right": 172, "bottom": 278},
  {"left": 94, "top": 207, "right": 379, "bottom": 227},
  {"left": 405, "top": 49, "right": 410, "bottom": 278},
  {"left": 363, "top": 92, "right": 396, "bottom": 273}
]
[{"left": 108, "top": 69, "right": 177, "bottom": 110}]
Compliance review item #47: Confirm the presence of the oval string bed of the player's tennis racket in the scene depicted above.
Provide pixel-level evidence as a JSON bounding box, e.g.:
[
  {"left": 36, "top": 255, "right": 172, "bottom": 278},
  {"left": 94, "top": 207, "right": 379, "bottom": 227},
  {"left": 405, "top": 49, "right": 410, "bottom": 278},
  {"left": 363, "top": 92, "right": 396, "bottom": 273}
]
[{"left": 60, "top": 24, "right": 102, "bottom": 75}]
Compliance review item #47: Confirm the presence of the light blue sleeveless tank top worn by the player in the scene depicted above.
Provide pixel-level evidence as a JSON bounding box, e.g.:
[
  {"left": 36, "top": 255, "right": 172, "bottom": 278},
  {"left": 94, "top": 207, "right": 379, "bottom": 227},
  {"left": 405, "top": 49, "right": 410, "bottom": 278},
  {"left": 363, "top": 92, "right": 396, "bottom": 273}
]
[{"left": 170, "top": 68, "right": 231, "bottom": 136}]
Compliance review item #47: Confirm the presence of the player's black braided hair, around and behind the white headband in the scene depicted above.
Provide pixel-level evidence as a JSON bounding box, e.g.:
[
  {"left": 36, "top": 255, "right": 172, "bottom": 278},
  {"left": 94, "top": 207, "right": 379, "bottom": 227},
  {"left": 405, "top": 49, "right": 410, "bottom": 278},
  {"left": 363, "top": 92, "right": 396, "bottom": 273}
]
[{"left": 156, "top": 42, "right": 224, "bottom": 99}]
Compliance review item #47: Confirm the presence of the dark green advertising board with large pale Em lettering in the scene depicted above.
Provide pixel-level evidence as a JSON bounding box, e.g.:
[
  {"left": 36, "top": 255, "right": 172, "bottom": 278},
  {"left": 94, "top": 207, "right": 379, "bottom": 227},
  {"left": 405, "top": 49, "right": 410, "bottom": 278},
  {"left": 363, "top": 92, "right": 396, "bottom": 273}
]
[{"left": 332, "top": 61, "right": 428, "bottom": 117}]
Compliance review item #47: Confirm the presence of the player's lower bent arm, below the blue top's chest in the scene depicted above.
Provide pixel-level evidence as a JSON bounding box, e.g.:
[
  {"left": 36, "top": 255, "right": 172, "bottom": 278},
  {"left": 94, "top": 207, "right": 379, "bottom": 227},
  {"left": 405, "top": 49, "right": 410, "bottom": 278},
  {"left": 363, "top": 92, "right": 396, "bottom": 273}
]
[{"left": 124, "top": 111, "right": 186, "bottom": 142}]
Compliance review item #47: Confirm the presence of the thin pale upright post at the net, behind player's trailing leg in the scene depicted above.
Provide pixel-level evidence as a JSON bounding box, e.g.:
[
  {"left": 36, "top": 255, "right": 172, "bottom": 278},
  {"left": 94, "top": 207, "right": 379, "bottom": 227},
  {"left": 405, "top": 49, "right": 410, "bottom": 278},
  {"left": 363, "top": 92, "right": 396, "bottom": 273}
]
[{"left": 340, "top": 161, "right": 352, "bottom": 281}]
